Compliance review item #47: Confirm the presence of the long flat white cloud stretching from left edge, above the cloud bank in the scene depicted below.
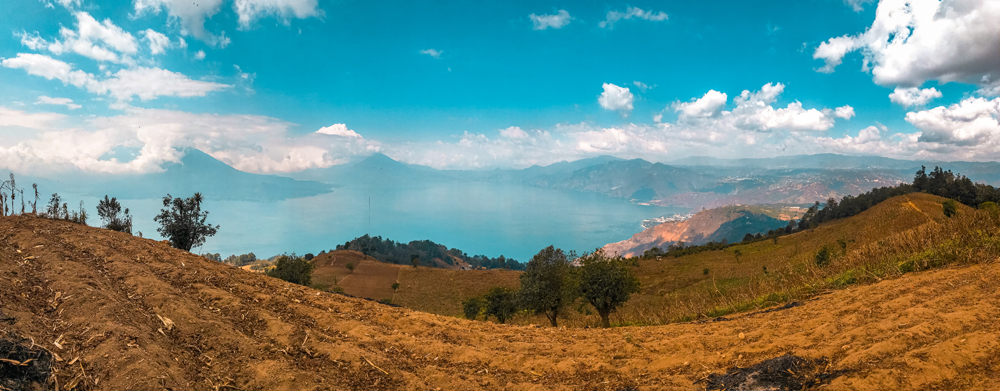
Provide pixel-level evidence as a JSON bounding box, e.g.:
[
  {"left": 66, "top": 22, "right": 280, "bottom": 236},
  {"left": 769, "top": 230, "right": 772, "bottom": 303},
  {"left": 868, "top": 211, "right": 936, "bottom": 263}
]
[{"left": 0, "top": 53, "right": 230, "bottom": 102}]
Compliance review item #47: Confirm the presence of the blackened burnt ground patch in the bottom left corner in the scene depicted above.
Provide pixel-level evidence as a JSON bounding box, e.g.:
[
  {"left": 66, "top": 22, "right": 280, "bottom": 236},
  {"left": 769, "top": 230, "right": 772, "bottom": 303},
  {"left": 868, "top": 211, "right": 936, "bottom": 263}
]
[{"left": 0, "top": 333, "right": 52, "bottom": 390}]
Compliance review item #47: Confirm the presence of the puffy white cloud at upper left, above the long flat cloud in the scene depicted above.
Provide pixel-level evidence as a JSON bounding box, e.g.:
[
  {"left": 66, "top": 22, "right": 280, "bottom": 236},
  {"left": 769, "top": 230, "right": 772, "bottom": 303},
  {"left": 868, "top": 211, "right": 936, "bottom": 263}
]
[{"left": 47, "top": 11, "right": 139, "bottom": 63}]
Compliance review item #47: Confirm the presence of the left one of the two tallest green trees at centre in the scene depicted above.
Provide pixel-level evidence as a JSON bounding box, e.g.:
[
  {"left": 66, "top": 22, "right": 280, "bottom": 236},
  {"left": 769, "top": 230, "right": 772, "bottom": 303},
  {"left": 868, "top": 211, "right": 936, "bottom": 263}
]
[{"left": 519, "top": 246, "right": 577, "bottom": 327}]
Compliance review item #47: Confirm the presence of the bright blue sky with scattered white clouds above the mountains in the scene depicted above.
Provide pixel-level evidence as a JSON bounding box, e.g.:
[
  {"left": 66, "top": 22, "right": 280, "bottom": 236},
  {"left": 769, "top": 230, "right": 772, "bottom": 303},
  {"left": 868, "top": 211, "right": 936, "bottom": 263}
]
[{"left": 0, "top": 0, "right": 1000, "bottom": 173}]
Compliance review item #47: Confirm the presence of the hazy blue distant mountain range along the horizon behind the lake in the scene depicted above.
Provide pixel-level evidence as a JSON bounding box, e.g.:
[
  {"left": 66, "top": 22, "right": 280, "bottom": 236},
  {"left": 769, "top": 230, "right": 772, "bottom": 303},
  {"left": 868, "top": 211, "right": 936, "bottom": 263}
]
[{"left": 9, "top": 149, "right": 1000, "bottom": 207}]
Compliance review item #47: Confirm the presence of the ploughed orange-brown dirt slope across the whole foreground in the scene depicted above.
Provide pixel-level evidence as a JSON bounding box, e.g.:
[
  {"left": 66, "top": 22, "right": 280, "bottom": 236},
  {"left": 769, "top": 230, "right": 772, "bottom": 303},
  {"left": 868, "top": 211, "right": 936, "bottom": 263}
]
[{"left": 0, "top": 217, "right": 1000, "bottom": 390}]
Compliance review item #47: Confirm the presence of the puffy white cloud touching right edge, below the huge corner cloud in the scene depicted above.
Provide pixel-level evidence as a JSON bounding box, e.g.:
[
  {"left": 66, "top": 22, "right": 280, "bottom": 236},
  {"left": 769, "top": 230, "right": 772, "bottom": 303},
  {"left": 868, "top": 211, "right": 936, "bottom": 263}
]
[{"left": 906, "top": 98, "right": 1000, "bottom": 147}]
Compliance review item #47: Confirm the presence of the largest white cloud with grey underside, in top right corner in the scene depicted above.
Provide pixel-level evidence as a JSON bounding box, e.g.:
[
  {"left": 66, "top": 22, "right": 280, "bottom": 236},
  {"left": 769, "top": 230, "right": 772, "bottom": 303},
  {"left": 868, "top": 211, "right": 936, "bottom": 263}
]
[{"left": 813, "top": 0, "right": 1000, "bottom": 87}]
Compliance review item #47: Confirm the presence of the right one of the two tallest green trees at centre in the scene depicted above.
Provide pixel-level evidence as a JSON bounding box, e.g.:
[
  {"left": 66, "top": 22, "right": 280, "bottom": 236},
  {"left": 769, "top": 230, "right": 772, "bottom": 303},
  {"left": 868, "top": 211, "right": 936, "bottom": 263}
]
[{"left": 580, "top": 249, "right": 639, "bottom": 327}]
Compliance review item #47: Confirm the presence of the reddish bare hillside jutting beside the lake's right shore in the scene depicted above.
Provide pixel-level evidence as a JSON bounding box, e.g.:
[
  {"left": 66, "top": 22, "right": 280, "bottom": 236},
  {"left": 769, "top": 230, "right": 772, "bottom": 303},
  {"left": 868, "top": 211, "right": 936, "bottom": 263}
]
[{"left": 604, "top": 206, "right": 798, "bottom": 258}]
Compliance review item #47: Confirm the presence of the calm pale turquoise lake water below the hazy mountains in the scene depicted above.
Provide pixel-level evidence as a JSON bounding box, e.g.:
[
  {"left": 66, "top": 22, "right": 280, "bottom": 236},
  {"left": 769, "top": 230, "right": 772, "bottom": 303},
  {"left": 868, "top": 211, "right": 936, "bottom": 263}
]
[{"left": 70, "top": 183, "right": 686, "bottom": 262}]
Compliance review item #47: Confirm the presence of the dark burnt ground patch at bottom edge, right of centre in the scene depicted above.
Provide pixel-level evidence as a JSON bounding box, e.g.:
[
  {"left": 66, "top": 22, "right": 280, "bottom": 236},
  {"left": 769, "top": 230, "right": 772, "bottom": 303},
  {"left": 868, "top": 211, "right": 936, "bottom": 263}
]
[{"left": 704, "top": 354, "right": 847, "bottom": 391}]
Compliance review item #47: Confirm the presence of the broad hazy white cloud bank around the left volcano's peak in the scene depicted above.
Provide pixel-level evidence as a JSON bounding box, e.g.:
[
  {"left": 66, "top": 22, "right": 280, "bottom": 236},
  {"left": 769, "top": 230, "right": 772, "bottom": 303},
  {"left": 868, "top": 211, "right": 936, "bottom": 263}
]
[{"left": 0, "top": 107, "right": 381, "bottom": 174}]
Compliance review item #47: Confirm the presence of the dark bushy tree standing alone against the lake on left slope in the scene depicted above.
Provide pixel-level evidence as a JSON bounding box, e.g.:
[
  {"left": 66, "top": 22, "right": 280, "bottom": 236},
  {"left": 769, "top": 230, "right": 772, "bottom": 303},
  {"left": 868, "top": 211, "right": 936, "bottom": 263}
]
[{"left": 153, "top": 193, "right": 219, "bottom": 251}]
